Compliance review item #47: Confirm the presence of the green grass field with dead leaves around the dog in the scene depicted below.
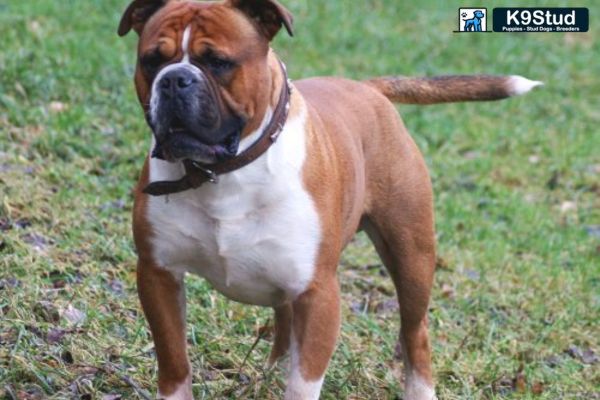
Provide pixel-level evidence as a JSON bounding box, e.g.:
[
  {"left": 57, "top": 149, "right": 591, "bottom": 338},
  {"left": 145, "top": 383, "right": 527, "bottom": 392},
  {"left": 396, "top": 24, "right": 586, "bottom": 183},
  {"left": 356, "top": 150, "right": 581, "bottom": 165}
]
[{"left": 0, "top": 0, "right": 600, "bottom": 400}]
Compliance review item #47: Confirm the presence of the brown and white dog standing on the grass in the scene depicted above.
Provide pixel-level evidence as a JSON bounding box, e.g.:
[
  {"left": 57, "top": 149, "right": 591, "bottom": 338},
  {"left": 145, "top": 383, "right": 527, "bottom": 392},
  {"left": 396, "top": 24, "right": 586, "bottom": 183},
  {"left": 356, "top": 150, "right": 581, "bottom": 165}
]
[{"left": 119, "top": 0, "right": 540, "bottom": 400}]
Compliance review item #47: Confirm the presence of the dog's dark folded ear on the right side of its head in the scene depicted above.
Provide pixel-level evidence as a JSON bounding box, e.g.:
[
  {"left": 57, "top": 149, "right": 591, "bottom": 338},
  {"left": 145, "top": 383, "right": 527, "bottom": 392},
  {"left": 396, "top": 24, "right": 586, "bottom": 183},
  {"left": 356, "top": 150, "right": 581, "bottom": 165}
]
[{"left": 229, "top": 0, "right": 294, "bottom": 41}]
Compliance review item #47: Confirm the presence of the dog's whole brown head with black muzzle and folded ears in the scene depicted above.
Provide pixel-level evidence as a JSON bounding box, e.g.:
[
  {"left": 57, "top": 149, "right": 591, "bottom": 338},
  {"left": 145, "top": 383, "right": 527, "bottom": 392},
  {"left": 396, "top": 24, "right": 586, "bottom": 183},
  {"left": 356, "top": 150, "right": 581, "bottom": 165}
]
[{"left": 119, "top": 0, "right": 292, "bottom": 164}]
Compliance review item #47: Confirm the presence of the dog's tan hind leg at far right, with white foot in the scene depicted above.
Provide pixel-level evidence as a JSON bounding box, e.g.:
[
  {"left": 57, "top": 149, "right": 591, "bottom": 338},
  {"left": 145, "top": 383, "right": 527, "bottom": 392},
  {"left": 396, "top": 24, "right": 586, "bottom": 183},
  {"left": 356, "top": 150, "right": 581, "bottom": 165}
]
[{"left": 361, "top": 135, "right": 435, "bottom": 400}]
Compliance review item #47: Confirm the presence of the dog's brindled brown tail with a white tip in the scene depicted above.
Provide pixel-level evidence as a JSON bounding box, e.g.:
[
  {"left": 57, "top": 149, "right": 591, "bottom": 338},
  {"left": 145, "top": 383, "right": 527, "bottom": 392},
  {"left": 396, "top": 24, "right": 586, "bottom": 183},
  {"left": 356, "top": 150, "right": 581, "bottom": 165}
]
[{"left": 365, "top": 75, "right": 543, "bottom": 104}]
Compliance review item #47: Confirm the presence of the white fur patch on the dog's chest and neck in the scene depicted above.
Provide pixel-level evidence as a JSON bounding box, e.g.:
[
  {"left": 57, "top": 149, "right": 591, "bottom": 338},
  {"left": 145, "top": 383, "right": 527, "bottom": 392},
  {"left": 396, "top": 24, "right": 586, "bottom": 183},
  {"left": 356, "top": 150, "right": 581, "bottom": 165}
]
[{"left": 147, "top": 105, "right": 321, "bottom": 306}]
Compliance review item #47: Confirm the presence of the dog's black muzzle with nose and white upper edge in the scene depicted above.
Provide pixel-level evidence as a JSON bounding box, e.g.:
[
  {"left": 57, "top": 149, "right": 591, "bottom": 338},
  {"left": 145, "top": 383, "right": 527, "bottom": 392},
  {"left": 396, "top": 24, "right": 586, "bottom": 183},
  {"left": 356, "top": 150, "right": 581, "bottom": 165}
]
[{"left": 149, "top": 62, "right": 243, "bottom": 164}]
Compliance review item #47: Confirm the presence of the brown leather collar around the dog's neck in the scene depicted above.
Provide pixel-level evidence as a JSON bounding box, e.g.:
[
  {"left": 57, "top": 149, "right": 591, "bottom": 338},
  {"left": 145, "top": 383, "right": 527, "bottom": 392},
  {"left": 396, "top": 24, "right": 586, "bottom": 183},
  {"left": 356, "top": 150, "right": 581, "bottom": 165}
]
[{"left": 143, "top": 61, "right": 292, "bottom": 196}]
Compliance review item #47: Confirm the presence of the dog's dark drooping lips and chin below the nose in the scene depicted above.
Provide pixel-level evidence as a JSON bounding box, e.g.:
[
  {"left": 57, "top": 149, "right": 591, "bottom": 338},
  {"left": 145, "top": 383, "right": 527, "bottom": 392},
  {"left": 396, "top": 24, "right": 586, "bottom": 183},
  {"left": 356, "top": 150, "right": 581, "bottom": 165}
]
[{"left": 152, "top": 123, "right": 241, "bottom": 164}]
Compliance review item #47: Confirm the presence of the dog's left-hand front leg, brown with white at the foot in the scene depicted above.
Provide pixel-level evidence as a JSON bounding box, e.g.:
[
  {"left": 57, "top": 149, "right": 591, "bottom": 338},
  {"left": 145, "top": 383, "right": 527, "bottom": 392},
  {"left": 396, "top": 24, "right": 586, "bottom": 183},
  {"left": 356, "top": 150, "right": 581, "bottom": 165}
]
[{"left": 137, "top": 260, "right": 193, "bottom": 400}]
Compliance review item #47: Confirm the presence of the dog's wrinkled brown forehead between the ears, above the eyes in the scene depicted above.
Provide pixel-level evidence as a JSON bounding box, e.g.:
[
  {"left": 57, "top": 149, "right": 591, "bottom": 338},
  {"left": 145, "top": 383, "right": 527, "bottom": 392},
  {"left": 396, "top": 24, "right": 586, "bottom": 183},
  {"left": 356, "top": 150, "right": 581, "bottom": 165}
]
[{"left": 139, "top": 1, "right": 266, "bottom": 56}]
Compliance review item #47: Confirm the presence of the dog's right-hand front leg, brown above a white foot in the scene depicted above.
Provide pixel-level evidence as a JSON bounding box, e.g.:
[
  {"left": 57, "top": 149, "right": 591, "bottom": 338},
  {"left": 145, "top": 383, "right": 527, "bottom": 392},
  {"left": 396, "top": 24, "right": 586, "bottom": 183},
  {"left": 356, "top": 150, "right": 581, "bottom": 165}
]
[{"left": 285, "top": 275, "right": 340, "bottom": 400}]
